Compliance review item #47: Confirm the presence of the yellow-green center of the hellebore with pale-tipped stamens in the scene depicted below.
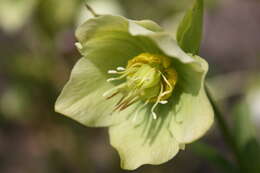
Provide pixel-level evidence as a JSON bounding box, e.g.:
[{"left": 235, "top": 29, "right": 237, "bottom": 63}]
[{"left": 103, "top": 53, "right": 178, "bottom": 119}]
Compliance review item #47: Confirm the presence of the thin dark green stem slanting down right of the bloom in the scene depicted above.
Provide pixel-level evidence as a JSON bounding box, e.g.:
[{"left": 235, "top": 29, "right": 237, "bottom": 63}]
[{"left": 205, "top": 85, "right": 242, "bottom": 172}]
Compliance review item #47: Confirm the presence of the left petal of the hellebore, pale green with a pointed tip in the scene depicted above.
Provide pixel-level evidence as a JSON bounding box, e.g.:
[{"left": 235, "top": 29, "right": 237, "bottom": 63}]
[{"left": 55, "top": 58, "right": 138, "bottom": 126}]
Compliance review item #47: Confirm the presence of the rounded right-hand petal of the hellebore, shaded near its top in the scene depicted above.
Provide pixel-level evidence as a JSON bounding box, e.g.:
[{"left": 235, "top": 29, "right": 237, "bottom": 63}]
[{"left": 168, "top": 57, "right": 214, "bottom": 143}]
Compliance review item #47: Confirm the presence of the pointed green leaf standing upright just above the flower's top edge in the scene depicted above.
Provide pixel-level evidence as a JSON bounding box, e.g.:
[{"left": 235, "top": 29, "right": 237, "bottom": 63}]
[{"left": 176, "top": 0, "right": 204, "bottom": 55}]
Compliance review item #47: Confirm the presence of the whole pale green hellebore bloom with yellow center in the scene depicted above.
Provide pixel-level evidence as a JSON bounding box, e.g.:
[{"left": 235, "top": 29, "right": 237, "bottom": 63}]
[{"left": 55, "top": 15, "right": 213, "bottom": 170}]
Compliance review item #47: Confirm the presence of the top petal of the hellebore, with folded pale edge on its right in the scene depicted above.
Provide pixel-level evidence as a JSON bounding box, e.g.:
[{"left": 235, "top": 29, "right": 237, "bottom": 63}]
[{"left": 76, "top": 15, "right": 201, "bottom": 75}]
